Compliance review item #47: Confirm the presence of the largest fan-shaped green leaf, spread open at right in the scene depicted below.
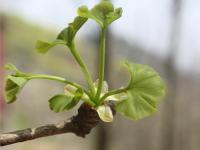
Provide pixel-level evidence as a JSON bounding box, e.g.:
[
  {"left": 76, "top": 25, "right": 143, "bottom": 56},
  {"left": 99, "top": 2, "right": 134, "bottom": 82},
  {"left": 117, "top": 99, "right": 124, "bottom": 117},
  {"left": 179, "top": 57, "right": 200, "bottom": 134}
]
[{"left": 116, "top": 62, "right": 165, "bottom": 120}]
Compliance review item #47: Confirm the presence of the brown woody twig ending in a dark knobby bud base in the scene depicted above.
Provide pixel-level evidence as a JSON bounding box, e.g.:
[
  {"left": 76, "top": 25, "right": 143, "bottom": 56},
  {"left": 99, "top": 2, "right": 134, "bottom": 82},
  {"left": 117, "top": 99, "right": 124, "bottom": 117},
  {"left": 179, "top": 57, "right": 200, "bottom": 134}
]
[{"left": 0, "top": 104, "right": 100, "bottom": 146}]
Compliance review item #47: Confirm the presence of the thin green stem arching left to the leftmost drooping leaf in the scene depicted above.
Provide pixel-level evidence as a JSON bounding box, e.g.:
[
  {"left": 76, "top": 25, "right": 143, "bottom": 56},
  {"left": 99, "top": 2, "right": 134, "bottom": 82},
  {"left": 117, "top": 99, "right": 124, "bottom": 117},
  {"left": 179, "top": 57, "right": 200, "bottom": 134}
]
[{"left": 27, "top": 74, "right": 91, "bottom": 98}]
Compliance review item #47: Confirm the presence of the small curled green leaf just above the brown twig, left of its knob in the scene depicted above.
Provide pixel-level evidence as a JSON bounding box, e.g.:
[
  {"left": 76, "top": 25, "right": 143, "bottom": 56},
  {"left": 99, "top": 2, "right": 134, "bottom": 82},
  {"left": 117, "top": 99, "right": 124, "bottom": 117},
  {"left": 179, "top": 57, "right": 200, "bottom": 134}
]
[{"left": 49, "top": 89, "right": 83, "bottom": 112}]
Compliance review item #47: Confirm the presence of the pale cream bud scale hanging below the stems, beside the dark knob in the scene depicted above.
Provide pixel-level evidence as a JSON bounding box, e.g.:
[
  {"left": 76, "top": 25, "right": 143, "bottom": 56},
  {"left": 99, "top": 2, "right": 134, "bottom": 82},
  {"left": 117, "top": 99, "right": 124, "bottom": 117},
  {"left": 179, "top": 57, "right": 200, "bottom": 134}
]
[{"left": 97, "top": 105, "right": 113, "bottom": 122}]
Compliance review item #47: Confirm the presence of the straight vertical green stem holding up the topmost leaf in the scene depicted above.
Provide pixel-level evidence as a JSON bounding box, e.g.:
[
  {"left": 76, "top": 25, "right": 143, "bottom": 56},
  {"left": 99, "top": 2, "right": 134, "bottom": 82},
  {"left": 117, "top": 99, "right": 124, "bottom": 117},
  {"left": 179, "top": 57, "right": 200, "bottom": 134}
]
[{"left": 95, "top": 27, "right": 106, "bottom": 100}]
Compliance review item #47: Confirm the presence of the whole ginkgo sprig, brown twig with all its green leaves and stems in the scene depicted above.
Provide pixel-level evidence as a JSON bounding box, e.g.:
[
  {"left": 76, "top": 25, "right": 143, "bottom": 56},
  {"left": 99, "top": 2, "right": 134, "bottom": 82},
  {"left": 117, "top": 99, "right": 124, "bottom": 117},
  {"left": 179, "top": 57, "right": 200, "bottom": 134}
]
[{"left": 0, "top": 1, "right": 165, "bottom": 146}]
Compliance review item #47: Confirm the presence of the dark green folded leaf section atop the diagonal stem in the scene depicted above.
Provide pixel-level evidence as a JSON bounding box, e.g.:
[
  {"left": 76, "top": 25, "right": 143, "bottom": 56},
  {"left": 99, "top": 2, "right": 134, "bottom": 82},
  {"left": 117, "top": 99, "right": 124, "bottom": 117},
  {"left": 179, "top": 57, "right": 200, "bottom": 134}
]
[{"left": 57, "top": 16, "right": 87, "bottom": 47}]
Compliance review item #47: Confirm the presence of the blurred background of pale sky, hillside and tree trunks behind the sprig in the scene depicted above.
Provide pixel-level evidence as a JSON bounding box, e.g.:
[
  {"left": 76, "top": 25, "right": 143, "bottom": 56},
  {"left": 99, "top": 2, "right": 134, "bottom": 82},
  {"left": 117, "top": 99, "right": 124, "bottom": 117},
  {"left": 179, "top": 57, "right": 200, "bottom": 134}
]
[{"left": 0, "top": 0, "right": 200, "bottom": 150}]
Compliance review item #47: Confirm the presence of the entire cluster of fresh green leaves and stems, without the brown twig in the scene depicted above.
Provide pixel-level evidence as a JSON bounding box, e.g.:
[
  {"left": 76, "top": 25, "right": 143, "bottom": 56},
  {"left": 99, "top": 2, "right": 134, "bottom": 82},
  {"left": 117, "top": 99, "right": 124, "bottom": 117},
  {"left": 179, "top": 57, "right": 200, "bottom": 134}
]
[{"left": 5, "top": 1, "right": 165, "bottom": 122}]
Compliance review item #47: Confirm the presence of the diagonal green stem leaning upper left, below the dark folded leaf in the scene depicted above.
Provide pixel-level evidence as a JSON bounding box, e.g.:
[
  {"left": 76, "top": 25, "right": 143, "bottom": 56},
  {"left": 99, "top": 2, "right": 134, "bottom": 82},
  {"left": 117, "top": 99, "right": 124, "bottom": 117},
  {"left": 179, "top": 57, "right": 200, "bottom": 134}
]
[{"left": 70, "top": 44, "right": 95, "bottom": 96}]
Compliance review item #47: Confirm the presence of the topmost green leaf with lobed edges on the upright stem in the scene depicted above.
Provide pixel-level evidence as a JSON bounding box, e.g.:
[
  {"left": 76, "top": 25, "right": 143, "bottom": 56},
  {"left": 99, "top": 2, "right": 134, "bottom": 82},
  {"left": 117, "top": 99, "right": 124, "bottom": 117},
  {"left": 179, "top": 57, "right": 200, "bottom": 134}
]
[{"left": 78, "top": 1, "right": 122, "bottom": 27}]
